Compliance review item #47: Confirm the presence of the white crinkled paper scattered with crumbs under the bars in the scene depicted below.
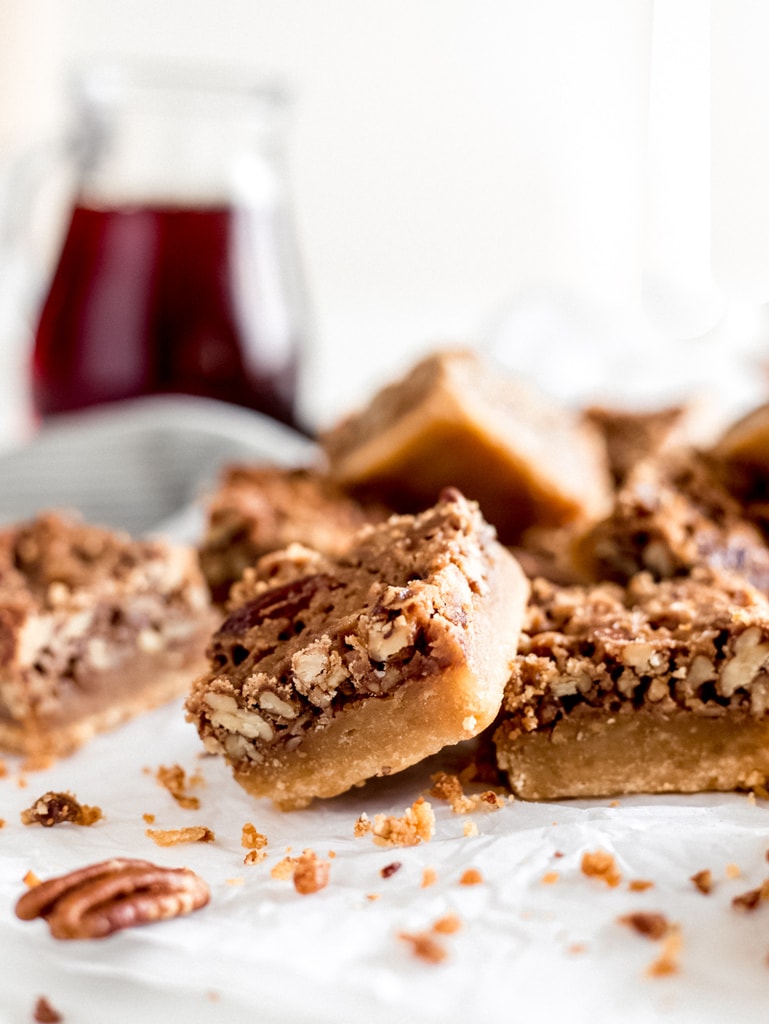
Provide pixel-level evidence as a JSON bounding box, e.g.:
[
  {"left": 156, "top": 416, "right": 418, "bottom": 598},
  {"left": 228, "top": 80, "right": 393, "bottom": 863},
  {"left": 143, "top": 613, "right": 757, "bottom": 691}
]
[{"left": 0, "top": 401, "right": 769, "bottom": 1024}]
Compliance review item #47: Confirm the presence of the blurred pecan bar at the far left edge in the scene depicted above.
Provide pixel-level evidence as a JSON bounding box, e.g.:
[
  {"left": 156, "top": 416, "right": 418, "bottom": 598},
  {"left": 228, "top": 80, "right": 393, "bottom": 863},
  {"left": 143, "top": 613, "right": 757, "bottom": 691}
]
[{"left": 0, "top": 513, "right": 215, "bottom": 756}]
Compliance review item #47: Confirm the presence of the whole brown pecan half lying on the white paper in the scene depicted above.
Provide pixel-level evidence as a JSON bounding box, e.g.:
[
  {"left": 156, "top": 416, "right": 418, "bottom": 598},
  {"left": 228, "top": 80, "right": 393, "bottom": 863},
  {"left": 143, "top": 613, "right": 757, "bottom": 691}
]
[{"left": 15, "top": 857, "right": 210, "bottom": 939}]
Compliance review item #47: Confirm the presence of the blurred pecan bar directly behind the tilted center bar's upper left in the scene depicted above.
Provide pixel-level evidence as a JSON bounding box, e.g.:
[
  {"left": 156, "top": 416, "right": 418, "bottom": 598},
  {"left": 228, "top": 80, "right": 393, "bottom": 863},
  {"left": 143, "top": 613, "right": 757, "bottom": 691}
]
[{"left": 199, "top": 465, "right": 384, "bottom": 602}]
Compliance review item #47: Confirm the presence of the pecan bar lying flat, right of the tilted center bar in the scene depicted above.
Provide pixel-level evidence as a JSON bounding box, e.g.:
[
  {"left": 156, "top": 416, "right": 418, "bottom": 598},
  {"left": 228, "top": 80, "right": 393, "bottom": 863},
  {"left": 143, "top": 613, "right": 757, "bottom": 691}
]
[{"left": 495, "top": 571, "right": 769, "bottom": 800}]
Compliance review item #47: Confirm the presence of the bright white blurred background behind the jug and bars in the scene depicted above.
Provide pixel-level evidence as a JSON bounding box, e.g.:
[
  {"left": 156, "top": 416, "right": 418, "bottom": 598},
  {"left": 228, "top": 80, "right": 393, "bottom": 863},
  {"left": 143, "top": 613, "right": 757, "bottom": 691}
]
[{"left": 0, "top": 0, "right": 769, "bottom": 434}]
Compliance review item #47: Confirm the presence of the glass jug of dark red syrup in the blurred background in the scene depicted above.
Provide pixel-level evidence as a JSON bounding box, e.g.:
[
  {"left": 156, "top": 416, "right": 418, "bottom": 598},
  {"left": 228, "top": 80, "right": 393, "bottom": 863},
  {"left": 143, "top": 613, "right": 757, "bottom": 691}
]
[{"left": 32, "top": 66, "right": 307, "bottom": 426}]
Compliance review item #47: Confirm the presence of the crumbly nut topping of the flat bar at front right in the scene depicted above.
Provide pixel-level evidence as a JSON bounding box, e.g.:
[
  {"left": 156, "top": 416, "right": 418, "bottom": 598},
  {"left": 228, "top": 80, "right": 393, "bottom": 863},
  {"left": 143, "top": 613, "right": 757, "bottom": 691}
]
[{"left": 503, "top": 570, "right": 769, "bottom": 735}]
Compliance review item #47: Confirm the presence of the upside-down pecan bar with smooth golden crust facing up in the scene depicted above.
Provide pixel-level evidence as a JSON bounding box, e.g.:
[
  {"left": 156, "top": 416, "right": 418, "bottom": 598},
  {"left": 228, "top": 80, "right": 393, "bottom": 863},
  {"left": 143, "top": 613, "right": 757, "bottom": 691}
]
[{"left": 322, "top": 351, "right": 611, "bottom": 544}]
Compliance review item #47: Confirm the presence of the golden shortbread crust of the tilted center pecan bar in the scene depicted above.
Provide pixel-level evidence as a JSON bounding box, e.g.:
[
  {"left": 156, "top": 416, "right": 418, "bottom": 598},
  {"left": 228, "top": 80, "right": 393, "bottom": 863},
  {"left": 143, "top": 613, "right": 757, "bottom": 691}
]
[{"left": 228, "top": 544, "right": 528, "bottom": 810}]
